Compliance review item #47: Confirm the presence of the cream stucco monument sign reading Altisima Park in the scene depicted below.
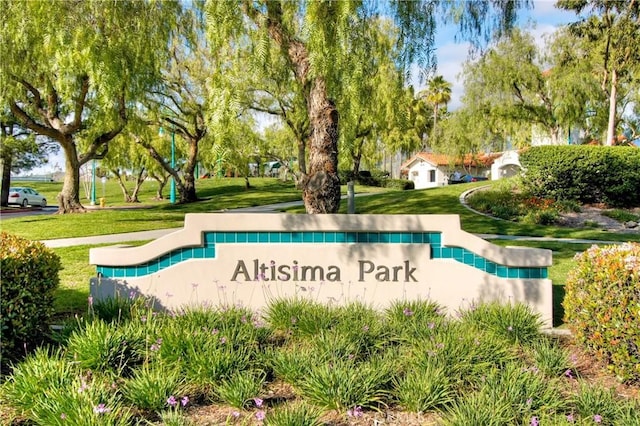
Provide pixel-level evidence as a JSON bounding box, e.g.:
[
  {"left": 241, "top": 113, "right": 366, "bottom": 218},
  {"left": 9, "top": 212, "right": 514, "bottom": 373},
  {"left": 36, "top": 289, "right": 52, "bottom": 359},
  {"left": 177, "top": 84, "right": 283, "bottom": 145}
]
[{"left": 90, "top": 213, "right": 552, "bottom": 327}]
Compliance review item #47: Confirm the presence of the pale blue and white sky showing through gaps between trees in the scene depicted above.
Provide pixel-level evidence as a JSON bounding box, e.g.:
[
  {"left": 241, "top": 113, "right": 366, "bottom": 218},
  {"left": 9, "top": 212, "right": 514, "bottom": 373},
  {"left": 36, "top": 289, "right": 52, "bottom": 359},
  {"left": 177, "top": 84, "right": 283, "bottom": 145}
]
[{"left": 25, "top": 0, "right": 576, "bottom": 175}]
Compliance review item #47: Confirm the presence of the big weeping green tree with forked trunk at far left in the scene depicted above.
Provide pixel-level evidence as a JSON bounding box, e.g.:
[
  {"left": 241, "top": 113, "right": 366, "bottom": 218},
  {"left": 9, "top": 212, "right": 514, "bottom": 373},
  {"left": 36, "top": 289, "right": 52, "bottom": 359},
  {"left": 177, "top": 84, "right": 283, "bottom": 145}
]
[{"left": 0, "top": 0, "right": 180, "bottom": 213}]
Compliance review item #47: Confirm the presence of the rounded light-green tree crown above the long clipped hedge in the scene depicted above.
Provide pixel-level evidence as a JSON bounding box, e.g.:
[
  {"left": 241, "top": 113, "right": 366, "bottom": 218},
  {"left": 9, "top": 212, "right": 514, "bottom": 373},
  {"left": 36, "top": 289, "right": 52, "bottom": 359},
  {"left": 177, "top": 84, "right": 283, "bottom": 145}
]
[{"left": 463, "top": 31, "right": 594, "bottom": 145}]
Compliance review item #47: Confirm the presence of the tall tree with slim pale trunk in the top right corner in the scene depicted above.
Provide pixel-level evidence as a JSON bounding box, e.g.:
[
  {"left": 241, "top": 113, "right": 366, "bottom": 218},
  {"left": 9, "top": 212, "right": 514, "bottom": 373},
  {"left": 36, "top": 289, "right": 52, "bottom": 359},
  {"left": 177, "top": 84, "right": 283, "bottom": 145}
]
[{"left": 557, "top": 0, "right": 640, "bottom": 145}]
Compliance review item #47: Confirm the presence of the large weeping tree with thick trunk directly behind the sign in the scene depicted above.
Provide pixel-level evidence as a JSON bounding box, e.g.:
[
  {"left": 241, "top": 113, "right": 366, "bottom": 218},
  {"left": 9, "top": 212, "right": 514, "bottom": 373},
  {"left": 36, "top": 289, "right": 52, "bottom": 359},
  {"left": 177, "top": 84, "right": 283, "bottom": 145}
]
[{"left": 206, "top": 0, "right": 529, "bottom": 213}]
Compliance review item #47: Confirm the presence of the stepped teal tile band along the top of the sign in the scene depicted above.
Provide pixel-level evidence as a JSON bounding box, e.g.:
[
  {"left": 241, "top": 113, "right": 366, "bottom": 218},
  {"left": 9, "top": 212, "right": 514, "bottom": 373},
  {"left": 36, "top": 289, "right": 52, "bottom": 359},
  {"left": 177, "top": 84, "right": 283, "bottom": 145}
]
[{"left": 96, "top": 231, "right": 548, "bottom": 279}]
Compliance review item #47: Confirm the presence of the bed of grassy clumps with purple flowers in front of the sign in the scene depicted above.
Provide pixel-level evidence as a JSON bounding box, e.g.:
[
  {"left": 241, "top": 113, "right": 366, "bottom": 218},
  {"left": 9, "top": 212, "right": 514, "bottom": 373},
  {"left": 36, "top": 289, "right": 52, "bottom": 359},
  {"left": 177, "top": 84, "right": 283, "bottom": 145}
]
[{"left": 0, "top": 300, "right": 638, "bottom": 426}]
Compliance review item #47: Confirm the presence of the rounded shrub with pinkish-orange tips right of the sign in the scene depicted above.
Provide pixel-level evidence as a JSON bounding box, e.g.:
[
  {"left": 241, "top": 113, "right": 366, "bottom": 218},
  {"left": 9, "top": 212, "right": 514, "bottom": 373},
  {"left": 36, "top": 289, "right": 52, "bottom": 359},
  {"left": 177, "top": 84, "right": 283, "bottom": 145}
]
[{"left": 563, "top": 243, "right": 640, "bottom": 381}]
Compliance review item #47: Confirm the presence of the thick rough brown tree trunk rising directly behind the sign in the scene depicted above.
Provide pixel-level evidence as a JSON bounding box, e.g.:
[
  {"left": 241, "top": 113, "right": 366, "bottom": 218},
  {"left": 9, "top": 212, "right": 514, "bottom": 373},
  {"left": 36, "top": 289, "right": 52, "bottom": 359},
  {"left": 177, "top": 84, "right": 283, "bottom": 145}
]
[{"left": 302, "top": 77, "right": 340, "bottom": 214}]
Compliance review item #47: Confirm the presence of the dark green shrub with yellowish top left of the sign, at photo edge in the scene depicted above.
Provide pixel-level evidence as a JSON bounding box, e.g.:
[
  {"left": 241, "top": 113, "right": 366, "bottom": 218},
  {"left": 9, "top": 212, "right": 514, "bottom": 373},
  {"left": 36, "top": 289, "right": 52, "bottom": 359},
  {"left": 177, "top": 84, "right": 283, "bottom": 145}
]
[{"left": 0, "top": 232, "right": 61, "bottom": 359}]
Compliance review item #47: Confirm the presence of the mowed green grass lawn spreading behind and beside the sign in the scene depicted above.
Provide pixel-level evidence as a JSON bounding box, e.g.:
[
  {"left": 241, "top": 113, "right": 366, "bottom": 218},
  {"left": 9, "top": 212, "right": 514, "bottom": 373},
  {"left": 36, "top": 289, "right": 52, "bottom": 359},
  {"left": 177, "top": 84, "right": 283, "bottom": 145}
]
[{"left": 1, "top": 178, "right": 638, "bottom": 325}]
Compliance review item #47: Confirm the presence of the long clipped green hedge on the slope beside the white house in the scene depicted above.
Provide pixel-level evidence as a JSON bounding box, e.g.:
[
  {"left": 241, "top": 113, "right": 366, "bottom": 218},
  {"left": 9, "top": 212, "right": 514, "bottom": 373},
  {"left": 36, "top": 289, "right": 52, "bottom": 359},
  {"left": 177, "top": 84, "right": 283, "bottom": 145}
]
[{"left": 520, "top": 145, "right": 640, "bottom": 207}]
